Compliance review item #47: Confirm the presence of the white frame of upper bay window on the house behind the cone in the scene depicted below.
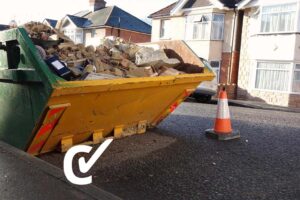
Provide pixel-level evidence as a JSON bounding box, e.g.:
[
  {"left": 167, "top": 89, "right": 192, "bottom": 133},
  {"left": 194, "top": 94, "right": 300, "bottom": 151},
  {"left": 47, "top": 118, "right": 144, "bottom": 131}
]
[{"left": 185, "top": 13, "right": 225, "bottom": 41}]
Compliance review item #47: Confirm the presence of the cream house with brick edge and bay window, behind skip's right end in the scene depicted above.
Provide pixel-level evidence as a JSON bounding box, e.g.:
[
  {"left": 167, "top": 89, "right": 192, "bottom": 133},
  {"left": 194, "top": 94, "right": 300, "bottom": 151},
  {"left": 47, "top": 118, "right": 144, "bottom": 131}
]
[{"left": 149, "top": 0, "right": 243, "bottom": 98}]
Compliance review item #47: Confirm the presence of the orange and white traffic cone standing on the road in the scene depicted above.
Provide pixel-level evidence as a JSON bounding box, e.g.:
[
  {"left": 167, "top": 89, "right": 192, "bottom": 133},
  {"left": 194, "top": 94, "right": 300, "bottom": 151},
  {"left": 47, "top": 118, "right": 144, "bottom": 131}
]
[{"left": 205, "top": 88, "right": 240, "bottom": 140}]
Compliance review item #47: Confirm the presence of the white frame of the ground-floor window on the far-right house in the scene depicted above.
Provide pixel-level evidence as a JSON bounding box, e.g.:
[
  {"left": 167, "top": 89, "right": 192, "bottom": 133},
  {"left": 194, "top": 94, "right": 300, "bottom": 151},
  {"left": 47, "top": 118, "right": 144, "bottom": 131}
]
[{"left": 251, "top": 60, "right": 300, "bottom": 95}]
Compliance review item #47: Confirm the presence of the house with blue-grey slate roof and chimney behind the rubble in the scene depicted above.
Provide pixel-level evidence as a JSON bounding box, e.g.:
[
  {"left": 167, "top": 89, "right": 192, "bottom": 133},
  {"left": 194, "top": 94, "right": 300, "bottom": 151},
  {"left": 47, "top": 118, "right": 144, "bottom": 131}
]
[{"left": 59, "top": 0, "right": 151, "bottom": 46}]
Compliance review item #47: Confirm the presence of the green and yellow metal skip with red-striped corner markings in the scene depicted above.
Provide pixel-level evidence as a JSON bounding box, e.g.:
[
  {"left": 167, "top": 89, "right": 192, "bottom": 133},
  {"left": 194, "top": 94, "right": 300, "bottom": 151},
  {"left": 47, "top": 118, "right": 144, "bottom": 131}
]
[{"left": 0, "top": 28, "right": 214, "bottom": 155}]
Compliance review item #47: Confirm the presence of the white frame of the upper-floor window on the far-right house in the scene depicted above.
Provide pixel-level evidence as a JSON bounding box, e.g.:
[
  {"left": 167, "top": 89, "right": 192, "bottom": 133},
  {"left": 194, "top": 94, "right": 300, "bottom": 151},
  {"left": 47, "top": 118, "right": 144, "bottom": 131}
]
[{"left": 258, "top": 0, "right": 300, "bottom": 35}]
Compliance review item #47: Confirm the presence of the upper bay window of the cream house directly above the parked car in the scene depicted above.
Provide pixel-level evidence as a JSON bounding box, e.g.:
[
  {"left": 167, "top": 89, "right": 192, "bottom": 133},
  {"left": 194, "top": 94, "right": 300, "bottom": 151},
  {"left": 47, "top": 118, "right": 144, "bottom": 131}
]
[{"left": 186, "top": 14, "right": 224, "bottom": 40}]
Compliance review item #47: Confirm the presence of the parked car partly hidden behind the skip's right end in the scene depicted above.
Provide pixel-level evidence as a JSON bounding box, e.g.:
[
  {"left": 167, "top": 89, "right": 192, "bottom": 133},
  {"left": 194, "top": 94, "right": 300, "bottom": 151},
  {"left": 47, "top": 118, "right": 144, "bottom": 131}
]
[{"left": 191, "top": 58, "right": 218, "bottom": 103}]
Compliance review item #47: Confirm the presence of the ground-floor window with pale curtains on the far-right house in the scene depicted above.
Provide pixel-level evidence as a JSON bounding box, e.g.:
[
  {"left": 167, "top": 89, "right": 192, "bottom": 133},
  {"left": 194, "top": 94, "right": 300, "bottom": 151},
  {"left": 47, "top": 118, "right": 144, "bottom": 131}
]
[{"left": 255, "top": 62, "right": 290, "bottom": 91}]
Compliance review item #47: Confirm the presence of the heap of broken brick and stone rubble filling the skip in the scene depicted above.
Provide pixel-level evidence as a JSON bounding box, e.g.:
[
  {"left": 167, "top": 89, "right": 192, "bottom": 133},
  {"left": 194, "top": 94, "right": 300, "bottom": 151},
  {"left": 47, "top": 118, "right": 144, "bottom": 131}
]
[{"left": 24, "top": 22, "right": 202, "bottom": 80}]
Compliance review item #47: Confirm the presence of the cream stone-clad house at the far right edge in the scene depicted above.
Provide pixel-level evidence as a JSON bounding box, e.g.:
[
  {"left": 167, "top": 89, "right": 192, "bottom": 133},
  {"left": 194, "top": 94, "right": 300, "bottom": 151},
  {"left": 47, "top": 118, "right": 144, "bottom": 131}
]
[{"left": 237, "top": 0, "right": 300, "bottom": 107}]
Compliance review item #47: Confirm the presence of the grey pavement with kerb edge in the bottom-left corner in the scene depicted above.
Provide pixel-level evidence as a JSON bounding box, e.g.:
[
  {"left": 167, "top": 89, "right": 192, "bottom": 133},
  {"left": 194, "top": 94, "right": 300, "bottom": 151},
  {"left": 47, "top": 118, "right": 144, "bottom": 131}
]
[{"left": 0, "top": 142, "right": 120, "bottom": 200}]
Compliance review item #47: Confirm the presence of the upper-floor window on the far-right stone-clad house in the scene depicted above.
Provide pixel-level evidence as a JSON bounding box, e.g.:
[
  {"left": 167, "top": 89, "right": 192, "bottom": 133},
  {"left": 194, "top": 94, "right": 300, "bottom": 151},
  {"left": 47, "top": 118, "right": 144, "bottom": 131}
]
[{"left": 260, "top": 3, "right": 297, "bottom": 33}]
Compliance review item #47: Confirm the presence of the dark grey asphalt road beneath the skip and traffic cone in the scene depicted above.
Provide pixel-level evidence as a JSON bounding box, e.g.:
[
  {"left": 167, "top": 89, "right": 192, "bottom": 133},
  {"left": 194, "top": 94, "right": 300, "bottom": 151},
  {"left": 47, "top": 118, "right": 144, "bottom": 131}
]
[{"left": 41, "top": 102, "right": 300, "bottom": 200}]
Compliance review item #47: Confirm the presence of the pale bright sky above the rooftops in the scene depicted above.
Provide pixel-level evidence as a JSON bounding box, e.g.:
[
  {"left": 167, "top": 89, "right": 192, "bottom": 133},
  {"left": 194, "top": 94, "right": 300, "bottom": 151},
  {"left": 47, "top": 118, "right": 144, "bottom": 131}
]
[{"left": 0, "top": 0, "right": 176, "bottom": 24}]
